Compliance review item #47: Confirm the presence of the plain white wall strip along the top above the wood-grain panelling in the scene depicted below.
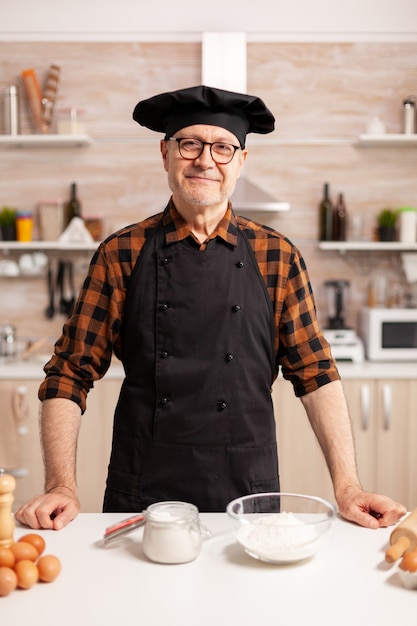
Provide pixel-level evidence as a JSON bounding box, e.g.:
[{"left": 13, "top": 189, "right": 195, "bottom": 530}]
[{"left": 0, "top": 0, "right": 417, "bottom": 41}]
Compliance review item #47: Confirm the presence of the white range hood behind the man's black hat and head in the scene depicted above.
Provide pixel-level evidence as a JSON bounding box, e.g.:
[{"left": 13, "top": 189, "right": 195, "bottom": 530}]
[{"left": 201, "top": 32, "right": 290, "bottom": 212}]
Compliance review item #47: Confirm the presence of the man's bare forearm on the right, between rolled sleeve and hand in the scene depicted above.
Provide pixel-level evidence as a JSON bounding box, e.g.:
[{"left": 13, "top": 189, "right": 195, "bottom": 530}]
[{"left": 301, "top": 381, "right": 360, "bottom": 498}]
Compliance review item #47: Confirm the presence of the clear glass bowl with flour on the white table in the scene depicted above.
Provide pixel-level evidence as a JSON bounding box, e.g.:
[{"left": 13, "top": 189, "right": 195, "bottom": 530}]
[{"left": 226, "top": 492, "right": 336, "bottom": 563}]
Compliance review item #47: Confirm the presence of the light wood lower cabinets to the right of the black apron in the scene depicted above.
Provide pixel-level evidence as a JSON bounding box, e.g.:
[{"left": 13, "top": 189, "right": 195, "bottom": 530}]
[{"left": 273, "top": 378, "right": 417, "bottom": 509}]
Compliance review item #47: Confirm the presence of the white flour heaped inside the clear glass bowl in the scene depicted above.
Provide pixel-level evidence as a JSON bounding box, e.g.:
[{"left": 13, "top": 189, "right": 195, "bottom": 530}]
[{"left": 237, "top": 512, "right": 319, "bottom": 563}]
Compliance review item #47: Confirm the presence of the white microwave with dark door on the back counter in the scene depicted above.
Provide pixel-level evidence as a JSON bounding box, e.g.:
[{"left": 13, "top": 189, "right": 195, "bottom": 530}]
[{"left": 360, "top": 307, "right": 417, "bottom": 361}]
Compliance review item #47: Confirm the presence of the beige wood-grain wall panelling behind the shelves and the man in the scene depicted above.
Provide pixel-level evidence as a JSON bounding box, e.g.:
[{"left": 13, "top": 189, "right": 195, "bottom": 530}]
[{"left": 0, "top": 42, "right": 417, "bottom": 336}]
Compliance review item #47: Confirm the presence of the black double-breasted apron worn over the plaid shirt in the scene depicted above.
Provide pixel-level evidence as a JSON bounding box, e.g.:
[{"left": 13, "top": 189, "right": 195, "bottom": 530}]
[{"left": 103, "top": 217, "right": 279, "bottom": 512}]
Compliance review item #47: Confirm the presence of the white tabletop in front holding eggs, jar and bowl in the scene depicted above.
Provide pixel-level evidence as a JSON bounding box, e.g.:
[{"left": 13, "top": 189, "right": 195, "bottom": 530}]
[{"left": 0, "top": 513, "right": 417, "bottom": 626}]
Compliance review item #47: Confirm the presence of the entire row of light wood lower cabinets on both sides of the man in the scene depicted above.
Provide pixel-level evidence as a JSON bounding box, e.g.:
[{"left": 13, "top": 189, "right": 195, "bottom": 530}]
[{"left": 0, "top": 373, "right": 417, "bottom": 513}]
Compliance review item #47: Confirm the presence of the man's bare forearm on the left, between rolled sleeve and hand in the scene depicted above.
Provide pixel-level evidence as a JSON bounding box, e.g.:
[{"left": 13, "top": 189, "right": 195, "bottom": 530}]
[{"left": 40, "top": 398, "right": 81, "bottom": 493}]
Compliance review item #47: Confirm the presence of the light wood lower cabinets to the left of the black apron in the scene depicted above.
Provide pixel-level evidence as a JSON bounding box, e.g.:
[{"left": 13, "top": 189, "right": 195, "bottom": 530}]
[{"left": 0, "top": 378, "right": 120, "bottom": 513}]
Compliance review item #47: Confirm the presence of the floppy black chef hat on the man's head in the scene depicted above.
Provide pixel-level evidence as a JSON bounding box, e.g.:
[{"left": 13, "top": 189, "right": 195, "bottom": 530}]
[{"left": 133, "top": 85, "right": 275, "bottom": 147}]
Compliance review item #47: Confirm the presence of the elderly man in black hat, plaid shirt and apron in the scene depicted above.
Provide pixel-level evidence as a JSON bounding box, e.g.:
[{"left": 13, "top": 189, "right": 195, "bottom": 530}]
[{"left": 16, "top": 86, "right": 405, "bottom": 529}]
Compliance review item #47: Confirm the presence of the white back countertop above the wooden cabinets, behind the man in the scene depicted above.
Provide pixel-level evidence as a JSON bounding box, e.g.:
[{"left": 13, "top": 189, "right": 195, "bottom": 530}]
[{"left": 0, "top": 357, "right": 417, "bottom": 381}]
